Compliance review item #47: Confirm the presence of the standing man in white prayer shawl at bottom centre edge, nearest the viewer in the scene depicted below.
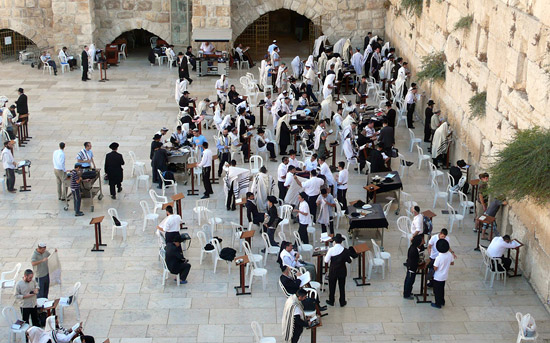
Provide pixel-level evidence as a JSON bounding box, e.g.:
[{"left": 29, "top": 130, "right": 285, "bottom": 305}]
[{"left": 282, "top": 289, "right": 308, "bottom": 343}]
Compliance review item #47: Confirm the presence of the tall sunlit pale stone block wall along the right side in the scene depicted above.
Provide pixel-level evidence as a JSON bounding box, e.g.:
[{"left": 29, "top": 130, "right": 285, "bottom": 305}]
[{"left": 385, "top": 0, "right": 550, "bottom": 306}]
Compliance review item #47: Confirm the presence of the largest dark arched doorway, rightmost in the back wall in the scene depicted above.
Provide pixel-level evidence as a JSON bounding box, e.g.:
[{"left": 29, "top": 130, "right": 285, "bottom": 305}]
[{"left": 235, "top": 9, "right": 321, "bottom": 60}]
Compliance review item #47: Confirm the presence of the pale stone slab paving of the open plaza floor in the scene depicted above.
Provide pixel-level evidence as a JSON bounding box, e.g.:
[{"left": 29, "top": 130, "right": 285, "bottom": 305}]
[{"left": 0, "top": 57, "right": 550, "bottom": 343}]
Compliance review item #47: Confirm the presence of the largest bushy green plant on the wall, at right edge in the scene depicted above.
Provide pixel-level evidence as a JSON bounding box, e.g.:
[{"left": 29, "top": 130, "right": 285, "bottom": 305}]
[{"left": 489, "top": 127, "right": 550, "bottom": 205}]
